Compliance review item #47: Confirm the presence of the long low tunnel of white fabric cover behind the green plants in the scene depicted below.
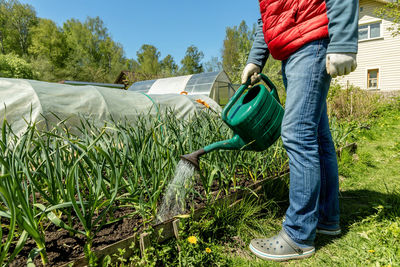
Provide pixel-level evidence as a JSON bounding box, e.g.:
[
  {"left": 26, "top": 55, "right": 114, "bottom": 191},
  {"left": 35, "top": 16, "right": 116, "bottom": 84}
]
[{"left": 0, "top": 78, "right": 221, "bottom": 135}]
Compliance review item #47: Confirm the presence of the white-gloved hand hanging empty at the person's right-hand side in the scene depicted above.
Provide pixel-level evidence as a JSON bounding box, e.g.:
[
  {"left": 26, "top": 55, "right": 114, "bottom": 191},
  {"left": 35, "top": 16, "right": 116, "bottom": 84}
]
[{"left": 326, "top": 53, "right": 357, "bottom": 78}]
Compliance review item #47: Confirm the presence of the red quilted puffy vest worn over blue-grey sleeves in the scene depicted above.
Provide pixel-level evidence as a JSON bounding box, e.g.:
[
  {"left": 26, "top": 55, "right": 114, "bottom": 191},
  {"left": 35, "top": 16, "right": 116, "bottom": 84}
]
[{"left": 259, "top": 0, "right": 328, "bottom": 60}]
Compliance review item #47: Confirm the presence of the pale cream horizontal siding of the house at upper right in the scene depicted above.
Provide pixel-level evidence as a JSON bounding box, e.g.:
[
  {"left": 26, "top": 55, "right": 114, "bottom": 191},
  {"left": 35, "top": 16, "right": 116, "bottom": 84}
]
[{"left": 337, "top": 0, "right": 400, "bottom": 91}]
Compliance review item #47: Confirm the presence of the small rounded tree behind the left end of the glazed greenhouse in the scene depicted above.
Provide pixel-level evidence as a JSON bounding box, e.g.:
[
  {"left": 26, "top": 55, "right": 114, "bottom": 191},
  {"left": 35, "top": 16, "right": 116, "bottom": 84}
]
[{"left": 136, "top": 44, "right": 161, "bottom": 80}]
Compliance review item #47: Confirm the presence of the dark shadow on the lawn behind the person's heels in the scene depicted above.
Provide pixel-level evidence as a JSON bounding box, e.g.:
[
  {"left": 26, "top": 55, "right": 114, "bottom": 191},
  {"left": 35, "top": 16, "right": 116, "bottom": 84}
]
[{"left": 315, "top": 190, "right": 400, "bottom": 247}]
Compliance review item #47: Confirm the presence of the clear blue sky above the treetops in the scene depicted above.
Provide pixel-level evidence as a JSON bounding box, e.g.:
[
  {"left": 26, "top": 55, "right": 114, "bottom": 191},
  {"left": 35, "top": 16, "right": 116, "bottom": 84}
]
[{"left": 20, "top": 0, "right": 259, "bottom": 64}]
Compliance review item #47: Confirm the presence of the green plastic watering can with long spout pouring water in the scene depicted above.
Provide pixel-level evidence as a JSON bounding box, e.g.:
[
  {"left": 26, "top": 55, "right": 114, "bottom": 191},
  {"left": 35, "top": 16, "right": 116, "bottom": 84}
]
[{"left": 181, "top": 74, "right": 284, "bottom": 169}]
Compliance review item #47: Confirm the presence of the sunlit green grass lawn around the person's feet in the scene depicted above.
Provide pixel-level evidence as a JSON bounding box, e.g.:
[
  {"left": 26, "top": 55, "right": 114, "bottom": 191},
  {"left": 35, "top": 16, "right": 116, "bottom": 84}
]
[{"left": 225, "top": 110, "right": 400, "bottom": 266}]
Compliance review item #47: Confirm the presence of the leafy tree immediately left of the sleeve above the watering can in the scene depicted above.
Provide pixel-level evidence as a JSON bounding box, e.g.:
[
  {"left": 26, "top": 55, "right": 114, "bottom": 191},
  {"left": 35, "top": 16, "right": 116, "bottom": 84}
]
[{"left": 222, "top": 21, "right": 255, "bottom": 83}]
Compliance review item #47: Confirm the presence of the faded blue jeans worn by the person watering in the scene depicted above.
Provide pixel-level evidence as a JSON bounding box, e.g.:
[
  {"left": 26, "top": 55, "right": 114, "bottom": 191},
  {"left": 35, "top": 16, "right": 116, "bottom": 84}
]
[{"left": 282, "top": 39, "right": 339, "bottom": 245}]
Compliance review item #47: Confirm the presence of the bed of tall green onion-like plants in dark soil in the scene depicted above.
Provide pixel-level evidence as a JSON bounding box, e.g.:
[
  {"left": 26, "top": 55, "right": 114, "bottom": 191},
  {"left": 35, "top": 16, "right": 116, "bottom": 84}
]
[{"left": 0, "top": 113, "right": 287, "bottom": 266}]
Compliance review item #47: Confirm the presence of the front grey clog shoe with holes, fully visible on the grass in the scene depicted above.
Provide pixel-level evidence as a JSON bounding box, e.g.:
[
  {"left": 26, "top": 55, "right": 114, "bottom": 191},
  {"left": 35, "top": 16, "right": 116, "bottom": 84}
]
[{"left": 250, "top": 230, "right": 315, "bottom": 261}]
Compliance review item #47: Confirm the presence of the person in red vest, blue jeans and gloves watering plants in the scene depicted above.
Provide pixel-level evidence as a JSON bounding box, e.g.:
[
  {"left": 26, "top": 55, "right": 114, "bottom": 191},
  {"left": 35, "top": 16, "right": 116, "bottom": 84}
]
[{"left": 242, "top": 0, "right": 358, "bottom": 261}]
